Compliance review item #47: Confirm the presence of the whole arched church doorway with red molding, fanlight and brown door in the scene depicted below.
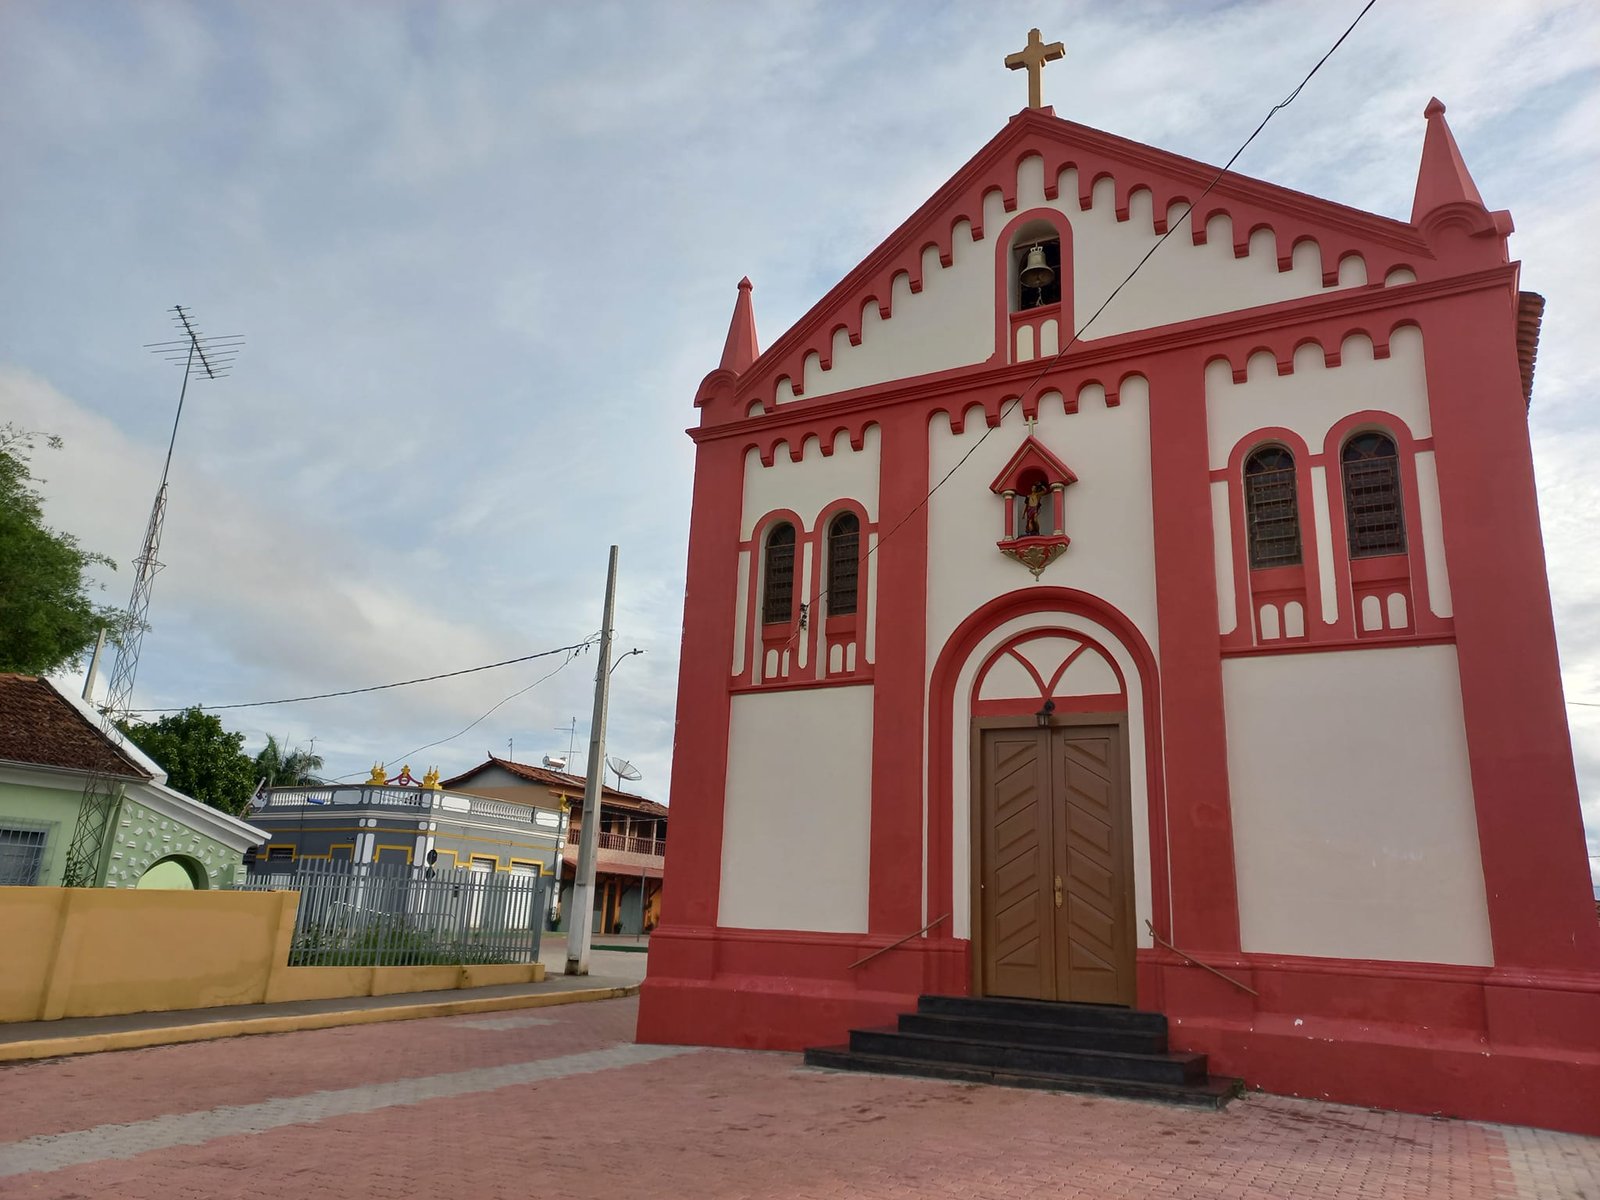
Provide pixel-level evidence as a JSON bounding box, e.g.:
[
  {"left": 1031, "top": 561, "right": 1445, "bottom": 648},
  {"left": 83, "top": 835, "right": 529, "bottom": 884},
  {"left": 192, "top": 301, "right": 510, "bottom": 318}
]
[{"left": 926, "top": 587, "right": 1168, "bottom": 1003}]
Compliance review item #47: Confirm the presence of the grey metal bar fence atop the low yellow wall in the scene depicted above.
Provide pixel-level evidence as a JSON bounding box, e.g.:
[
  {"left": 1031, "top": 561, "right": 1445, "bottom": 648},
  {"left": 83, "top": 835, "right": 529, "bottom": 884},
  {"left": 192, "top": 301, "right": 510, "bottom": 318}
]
[{"left": 238, "top": 859, "right": 552, "bottom": 966}]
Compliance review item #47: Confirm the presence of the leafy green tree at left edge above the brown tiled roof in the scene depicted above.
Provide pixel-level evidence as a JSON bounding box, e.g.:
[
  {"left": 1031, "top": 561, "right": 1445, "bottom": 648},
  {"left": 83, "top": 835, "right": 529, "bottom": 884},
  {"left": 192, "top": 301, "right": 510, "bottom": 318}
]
[{"left": 0, "top": 424, "right": 117, "bottom": 675}]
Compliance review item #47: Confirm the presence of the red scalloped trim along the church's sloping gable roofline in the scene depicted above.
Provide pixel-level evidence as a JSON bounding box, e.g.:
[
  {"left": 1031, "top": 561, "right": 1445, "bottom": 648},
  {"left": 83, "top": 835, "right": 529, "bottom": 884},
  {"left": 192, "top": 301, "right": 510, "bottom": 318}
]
[{"left": 736, "top": 109, "right": 1430, "bottom": 416}]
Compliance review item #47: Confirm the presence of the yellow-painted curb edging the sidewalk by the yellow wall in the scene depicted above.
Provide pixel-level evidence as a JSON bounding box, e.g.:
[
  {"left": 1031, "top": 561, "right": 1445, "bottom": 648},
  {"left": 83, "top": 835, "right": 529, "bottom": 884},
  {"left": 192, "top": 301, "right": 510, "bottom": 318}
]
[{"left": 0, "top": 984, "right": 640, "bottom": 1062}]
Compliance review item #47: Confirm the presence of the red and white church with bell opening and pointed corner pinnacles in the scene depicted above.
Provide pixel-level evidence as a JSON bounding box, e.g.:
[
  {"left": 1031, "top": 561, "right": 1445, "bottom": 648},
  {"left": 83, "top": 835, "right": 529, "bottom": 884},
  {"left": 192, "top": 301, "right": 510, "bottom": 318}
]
[{"left": 638, "top": 40, "right": 1600, "bottom": 1133}]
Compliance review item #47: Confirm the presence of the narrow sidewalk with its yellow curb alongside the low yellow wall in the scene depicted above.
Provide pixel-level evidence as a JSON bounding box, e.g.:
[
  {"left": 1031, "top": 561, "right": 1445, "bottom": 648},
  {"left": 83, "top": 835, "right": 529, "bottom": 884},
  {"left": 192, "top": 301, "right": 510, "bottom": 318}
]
[{"left": 0, "top": 968, "right": 638, "bottom": 1062}]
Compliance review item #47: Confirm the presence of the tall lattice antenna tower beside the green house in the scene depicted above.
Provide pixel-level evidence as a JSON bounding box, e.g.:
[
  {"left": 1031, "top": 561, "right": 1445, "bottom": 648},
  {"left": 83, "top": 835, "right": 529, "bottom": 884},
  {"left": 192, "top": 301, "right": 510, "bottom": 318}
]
[{"left": 64, "top": 304, "right": 245, "bottom": 888}]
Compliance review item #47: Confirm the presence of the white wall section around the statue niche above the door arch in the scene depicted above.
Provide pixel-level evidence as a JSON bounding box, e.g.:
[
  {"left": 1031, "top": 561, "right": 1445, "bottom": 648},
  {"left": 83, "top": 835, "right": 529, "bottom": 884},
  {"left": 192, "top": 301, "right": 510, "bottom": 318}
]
[{"left": 928, "top": 379, "right": 1157, "bottom": 678}]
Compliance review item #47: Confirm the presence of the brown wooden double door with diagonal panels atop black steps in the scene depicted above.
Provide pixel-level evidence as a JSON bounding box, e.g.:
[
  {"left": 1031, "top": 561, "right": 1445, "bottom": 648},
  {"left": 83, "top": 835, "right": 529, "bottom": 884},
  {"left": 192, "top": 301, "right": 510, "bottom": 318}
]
[{"left": 973, "top": 717, "right": 1134, "bottom": 1006}]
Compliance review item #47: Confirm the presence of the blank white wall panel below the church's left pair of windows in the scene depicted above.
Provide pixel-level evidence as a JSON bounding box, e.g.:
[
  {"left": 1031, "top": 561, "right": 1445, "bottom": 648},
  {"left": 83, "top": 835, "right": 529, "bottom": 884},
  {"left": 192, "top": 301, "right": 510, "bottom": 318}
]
[{"left": 717, "top": 686, "right": 872, "bottom": 933}]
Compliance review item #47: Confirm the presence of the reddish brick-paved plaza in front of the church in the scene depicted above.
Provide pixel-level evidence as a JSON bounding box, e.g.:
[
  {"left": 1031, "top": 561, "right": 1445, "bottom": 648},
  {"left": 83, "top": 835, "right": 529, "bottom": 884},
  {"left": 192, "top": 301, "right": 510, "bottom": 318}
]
[{"left": 0, "top": 1000, "right": 1600, "bottom": 1200}]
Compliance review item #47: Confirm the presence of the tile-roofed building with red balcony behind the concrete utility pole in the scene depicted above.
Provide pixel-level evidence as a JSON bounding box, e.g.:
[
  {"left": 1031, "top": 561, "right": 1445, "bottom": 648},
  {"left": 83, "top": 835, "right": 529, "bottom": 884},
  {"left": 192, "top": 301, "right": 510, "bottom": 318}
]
[{"left": 443, "top": 755, "right": 667, "bottom": 934}]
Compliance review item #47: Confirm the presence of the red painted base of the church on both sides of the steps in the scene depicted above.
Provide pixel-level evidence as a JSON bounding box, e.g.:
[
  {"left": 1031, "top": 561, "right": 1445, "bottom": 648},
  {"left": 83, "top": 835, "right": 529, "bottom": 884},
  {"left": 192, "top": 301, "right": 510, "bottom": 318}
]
[{"left": 638, "top": 928, "right": 1600, "bottom": 1136}]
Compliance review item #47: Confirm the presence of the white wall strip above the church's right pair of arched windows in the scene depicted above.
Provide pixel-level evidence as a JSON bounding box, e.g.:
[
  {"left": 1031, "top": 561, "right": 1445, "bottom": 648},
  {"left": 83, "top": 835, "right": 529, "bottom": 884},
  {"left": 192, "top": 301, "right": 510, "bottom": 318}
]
[{"left": 1205, "top": 326, "right": 1434, "bottom": 470}]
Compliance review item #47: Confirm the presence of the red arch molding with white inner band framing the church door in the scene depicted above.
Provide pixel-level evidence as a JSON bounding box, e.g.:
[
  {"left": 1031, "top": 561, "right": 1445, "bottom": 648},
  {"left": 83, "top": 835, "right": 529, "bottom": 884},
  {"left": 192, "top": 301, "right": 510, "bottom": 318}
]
[{"left": 923, "top": 586, "right": 1171, "bottom": 946}]
